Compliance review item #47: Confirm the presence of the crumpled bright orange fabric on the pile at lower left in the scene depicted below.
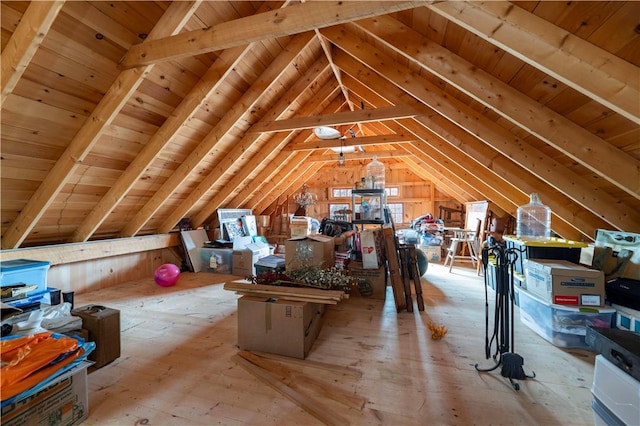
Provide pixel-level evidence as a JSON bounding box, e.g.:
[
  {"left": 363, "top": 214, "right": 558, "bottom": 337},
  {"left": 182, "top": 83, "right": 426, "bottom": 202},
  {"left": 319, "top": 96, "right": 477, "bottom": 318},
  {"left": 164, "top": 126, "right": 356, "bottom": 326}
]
[{"left": 0, "top": 334, "right": 78, "bottom": 390}]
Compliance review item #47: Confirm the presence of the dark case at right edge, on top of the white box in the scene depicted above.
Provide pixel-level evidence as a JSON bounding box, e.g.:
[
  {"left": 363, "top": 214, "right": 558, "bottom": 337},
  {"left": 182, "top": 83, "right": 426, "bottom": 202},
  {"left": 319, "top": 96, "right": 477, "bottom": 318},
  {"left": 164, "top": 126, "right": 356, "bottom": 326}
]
[{"left": 585, "top": 326, "right": 640, "bottom": 380}]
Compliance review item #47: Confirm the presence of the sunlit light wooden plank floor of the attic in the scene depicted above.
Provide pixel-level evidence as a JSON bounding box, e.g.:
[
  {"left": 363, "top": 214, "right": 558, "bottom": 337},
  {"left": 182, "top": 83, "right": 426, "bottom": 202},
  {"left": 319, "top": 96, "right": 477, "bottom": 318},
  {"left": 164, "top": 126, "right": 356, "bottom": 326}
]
[{"left": 76, "top": 263, "right": 595, "bottom": 426}]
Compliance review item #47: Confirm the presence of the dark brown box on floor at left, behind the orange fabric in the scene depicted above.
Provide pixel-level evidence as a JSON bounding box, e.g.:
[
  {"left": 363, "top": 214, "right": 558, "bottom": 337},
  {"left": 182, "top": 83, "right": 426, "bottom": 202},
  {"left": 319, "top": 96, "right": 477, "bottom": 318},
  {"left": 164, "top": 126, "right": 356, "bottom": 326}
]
[{"left": 71, "top": 305, "right": 120, "bottom": 368}]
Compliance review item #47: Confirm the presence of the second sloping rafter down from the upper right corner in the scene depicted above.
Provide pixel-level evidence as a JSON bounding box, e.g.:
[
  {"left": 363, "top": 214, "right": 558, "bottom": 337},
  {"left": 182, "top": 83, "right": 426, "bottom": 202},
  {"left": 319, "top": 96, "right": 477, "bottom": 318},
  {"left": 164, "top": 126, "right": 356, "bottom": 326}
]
[{"left": 358, "top": 16, "right": 640, "bottom": 198}]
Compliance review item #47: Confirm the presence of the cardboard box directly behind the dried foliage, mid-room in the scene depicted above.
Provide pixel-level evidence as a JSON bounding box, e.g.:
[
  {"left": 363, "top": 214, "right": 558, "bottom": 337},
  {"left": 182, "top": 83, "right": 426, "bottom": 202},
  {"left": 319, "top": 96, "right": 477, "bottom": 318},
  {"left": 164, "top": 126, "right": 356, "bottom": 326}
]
[{"left": 285, "top": 234, "right": 335, "bottom": 269}]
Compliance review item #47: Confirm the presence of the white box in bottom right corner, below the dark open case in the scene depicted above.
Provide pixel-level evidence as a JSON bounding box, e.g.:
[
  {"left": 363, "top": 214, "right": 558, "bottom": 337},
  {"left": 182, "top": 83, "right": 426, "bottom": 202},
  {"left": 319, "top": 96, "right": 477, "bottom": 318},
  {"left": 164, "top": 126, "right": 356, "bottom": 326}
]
[{"left": 591, "top": 355, "right": 640, "bottom": 425}]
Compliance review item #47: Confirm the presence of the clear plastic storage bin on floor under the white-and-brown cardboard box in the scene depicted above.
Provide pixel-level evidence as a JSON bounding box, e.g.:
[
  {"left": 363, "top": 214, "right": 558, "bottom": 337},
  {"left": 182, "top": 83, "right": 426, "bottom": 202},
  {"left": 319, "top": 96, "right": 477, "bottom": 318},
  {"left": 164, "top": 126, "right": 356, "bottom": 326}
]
[{"left": 515, "top": 287, "right": 616, "bottom": 350}]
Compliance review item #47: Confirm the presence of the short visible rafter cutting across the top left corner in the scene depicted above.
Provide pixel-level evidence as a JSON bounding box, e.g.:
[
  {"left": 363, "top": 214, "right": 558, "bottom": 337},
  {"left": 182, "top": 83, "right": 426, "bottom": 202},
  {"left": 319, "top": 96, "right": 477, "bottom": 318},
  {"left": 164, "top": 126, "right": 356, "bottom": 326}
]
[{"left": 0, "top": 1, "right": 64, "bottom": 106}]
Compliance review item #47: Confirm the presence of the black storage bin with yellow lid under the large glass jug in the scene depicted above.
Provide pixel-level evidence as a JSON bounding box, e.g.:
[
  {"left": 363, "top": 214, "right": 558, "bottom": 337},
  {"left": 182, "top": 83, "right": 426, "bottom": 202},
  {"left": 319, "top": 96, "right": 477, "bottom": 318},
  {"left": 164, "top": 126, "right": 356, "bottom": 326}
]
[{"left": 503, "top": 235, "right": 588, "bottom": 274}]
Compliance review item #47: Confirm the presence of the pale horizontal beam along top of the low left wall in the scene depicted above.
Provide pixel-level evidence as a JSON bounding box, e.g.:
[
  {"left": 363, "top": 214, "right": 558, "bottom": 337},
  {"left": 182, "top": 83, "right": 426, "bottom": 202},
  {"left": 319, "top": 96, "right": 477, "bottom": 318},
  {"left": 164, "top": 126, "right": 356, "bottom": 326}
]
[{"left": 0, "top": 234, "right": 181, "bottom": 266}]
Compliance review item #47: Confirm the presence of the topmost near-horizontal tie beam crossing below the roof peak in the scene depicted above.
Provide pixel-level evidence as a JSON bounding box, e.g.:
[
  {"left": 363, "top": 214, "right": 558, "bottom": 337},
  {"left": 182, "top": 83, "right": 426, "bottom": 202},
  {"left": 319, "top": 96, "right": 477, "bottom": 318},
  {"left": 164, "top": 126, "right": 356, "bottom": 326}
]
[{"left": 120, "top": 1, "right": 426, "bottom": 69}]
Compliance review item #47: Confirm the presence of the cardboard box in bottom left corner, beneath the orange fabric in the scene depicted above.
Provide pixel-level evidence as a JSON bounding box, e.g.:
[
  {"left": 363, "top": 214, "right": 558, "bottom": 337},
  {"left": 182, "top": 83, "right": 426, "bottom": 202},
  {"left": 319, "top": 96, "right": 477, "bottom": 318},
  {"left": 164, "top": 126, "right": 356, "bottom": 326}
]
[{"left": 0, "top": 362, "right": 91, "bottom": 426}]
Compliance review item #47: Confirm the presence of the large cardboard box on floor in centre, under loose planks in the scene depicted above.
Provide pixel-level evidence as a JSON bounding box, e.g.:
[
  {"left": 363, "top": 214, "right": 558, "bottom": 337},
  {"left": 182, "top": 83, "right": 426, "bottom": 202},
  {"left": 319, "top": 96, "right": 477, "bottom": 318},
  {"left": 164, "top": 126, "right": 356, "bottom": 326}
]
[{"left": 238, "top": 296, "right": 324, "bottom": 359}]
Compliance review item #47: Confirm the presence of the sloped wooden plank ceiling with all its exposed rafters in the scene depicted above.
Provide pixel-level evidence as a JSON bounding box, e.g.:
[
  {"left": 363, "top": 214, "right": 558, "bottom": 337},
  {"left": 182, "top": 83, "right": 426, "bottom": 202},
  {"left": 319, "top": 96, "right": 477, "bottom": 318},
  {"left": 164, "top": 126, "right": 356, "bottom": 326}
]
[{"left": 0, "top": 1, "right": 640, "bottom": 249}]
